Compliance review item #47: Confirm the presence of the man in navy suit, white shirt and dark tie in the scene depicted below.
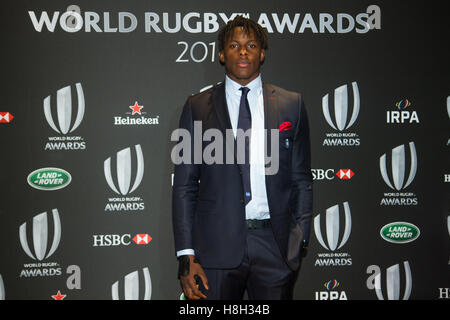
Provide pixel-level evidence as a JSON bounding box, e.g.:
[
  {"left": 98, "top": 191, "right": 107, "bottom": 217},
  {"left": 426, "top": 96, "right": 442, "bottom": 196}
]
[{"left": 172, "top": 17, "right": 312, "bottom": 300}]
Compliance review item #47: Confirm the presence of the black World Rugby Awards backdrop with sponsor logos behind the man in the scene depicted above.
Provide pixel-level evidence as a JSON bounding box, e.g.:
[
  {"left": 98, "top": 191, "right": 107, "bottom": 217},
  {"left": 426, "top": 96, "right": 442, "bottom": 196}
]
[{"left": 0, "top": 0, "right": 450, "bottom": 300}]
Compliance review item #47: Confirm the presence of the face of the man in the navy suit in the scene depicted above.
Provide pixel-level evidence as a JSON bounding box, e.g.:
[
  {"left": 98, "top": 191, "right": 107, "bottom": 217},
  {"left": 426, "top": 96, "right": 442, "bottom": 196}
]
[{"left": 219, "top": 27, "right": 265, "bottom": 86}]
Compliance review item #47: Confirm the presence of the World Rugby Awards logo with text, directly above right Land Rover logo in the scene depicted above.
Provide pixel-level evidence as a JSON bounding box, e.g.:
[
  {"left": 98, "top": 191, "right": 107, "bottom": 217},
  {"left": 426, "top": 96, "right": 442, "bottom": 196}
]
[{"left": 380, "top": 142, "right": 418, "bottom": 206}]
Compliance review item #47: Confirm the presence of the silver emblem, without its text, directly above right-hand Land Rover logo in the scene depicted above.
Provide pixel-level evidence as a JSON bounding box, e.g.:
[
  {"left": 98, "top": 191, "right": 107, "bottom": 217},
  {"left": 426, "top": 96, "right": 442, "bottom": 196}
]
[{"left": 380, "top": 142, "right": 417, "bottom": 191}]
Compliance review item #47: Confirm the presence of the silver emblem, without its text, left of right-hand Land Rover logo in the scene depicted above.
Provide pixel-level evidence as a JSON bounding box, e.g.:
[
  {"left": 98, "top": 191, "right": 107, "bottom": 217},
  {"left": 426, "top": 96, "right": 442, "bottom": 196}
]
[{"left": 314, "top": 202, "right": 352, "bottom": 251}]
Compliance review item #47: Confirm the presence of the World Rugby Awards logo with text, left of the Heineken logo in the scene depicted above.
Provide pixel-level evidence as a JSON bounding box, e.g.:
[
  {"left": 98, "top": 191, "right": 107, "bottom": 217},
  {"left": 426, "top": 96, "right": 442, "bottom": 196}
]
[{"left": 44, "top": 83, "right": 86, "bottom": 150}]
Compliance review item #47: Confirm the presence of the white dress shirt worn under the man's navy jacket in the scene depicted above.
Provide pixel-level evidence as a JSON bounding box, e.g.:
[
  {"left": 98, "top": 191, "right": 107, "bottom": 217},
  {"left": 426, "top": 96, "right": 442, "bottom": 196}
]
[{"left": 177, "top": 74, "right": 270, "bottom": 257}]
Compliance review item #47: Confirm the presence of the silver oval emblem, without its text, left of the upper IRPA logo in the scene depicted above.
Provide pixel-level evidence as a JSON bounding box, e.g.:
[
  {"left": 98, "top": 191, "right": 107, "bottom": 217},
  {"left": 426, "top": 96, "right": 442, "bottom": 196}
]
[{"left": 322, "top": 82, "right": 360, "bottom": 131}]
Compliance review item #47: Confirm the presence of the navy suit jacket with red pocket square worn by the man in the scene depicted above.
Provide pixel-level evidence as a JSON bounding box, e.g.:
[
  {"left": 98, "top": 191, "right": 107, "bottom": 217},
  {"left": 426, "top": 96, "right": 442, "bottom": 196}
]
[{"left": 172, "top": 82, "right": 312, "bottom": 270}]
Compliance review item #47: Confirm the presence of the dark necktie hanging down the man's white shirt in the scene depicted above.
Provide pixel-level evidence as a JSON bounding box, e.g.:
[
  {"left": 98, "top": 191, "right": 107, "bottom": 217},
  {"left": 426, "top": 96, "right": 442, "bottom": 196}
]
[{"left": 238, "top": 87, "right": 252, "bottom": 205}]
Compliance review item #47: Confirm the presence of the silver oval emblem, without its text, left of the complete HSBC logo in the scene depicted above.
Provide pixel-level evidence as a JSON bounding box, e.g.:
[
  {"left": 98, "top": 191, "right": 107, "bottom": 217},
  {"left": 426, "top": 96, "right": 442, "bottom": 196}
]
[{"left": 19, "top": 209, "right": 61, "bottom": 261}]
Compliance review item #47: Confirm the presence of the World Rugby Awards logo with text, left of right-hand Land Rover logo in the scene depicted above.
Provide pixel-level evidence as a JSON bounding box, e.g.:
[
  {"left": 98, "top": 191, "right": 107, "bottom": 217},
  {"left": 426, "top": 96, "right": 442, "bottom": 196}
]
[{"left": 314, "top": 202, "right": 352, "bottom": 266}]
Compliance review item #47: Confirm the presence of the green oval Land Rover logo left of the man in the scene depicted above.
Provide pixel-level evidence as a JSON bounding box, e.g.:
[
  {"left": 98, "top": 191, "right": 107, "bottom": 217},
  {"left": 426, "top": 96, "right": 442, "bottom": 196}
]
[{"left": 27, "top": 168, "right": 72, "bottom": 191}]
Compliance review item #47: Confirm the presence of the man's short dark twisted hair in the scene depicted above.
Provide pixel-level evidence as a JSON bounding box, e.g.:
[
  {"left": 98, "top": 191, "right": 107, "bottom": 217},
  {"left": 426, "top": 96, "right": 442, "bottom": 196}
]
[{"left": 218, "top": 16, "right": 269, "bottom": 52}]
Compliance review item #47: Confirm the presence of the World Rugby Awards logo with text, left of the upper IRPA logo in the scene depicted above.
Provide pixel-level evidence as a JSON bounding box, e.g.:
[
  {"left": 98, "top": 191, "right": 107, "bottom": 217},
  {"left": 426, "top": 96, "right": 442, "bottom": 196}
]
[{"left": 322, "top": 82, "right": 360, "bottom": 147}]
